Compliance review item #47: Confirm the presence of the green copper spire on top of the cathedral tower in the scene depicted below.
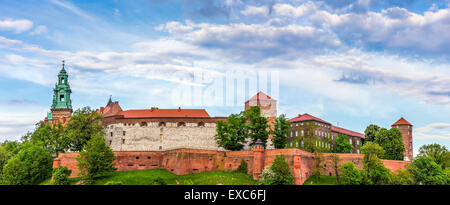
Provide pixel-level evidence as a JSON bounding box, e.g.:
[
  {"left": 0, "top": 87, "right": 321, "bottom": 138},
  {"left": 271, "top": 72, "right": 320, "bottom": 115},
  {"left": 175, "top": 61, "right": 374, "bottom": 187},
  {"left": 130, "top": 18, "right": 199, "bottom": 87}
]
[{"left": 52, "top": 61, "right": 72, "bottom": 109}]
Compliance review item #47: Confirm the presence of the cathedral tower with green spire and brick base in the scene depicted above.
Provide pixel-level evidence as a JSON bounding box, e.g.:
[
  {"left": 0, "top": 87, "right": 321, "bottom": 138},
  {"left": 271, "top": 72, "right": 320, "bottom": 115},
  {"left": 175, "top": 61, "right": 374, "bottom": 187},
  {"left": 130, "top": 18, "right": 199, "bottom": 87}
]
[{"left": 46, "top": 61, "right": 72, "bottom": 123}]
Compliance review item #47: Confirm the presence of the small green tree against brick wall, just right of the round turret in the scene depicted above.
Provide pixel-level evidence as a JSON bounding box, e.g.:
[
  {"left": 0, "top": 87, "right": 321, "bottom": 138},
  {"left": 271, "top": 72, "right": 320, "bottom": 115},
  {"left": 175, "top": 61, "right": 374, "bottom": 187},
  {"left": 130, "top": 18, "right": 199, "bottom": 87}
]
[{"left": 270, "top": 155, "right": 294, "bottom": 185}]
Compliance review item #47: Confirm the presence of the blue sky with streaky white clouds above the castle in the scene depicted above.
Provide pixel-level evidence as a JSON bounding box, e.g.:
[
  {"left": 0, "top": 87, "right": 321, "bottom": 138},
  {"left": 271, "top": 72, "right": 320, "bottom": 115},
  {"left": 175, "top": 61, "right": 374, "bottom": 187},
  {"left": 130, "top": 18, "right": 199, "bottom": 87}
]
[{"left": 0, "top": 0, "right": 450, "bottom": 154}]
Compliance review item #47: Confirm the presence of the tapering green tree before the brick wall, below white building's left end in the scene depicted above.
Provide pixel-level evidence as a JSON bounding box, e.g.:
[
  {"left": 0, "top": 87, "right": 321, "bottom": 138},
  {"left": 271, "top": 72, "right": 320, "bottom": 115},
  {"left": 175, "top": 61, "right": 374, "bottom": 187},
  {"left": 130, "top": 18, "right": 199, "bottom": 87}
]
[{"left": 77, "top": 135, "right": 116, "bottom": 183}]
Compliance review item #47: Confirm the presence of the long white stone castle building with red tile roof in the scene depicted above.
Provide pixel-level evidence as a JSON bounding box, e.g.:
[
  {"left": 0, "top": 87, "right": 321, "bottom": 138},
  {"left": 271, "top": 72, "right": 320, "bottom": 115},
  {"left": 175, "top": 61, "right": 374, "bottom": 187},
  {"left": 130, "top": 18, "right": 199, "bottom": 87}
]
[{"left": 98, "top": 99, "right": 226, "bottom": 151}]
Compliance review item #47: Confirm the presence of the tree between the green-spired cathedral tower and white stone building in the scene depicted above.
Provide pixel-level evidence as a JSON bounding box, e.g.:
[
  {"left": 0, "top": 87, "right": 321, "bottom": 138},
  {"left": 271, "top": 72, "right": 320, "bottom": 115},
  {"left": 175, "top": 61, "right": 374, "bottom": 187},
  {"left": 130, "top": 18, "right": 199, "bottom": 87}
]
[{"left": 66, "top": 107, "right": 105, "bottom": 152}]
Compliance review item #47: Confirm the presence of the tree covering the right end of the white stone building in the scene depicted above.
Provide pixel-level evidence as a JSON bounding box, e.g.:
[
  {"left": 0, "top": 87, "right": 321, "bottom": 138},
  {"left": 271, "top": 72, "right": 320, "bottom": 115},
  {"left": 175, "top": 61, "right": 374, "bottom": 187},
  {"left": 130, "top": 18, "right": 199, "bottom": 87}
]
[{"left": 214, "top": 113, "right": 248, "bottom": 151}]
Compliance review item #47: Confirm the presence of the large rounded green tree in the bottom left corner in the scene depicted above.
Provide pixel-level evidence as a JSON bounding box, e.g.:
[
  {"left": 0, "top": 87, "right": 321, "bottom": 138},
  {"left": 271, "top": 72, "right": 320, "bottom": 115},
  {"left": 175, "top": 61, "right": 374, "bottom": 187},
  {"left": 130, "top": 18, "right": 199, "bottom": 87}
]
[{"left": 3, "top": 143, "right": 53, "bottom": 185}]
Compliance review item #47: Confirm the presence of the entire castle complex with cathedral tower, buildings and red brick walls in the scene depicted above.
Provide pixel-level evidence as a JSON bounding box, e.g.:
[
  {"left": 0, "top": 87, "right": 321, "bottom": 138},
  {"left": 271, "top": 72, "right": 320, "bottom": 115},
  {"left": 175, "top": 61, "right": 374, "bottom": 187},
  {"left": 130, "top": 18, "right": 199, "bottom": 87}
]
[{"left": 50, "top": 63, "right": 413, "bottom": 184}]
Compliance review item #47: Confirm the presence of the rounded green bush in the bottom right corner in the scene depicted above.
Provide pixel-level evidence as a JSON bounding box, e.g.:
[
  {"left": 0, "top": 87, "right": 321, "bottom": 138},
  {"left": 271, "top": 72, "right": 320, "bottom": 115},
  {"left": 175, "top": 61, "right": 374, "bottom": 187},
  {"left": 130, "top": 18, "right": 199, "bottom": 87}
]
[{"left": 408, "top": 156, "right": 447, "bottom": 185}]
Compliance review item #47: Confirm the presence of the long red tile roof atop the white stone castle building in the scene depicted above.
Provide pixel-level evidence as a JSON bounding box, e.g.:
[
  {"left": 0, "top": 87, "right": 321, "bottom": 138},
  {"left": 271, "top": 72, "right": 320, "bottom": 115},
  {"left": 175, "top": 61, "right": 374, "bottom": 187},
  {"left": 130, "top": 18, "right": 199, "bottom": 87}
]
[{"left": 116, "top": 108, "right": 210, "bottom": 118}]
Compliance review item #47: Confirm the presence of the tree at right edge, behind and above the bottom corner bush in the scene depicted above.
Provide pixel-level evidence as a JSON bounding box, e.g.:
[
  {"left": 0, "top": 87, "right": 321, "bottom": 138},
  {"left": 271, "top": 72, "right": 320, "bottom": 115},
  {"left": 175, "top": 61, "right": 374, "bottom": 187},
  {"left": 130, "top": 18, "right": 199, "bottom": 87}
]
[{"left": 417, "top": 143, "right": 450, "bottom": 169}]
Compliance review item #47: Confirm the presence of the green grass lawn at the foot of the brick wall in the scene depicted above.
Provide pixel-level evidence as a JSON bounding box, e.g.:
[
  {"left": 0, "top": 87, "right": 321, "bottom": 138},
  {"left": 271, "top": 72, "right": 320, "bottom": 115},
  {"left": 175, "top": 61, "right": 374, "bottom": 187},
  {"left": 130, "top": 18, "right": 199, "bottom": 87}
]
[{"left": 45, "top": 169, "right": 257, "bottom": 185}]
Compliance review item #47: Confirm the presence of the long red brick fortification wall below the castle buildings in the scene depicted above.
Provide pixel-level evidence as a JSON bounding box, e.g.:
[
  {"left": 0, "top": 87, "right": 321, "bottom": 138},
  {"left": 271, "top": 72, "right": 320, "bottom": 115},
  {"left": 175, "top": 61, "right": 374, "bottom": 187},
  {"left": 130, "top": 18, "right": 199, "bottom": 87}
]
[{"left": 53, "top": 147, "right": 409, "bottom": 185}]
